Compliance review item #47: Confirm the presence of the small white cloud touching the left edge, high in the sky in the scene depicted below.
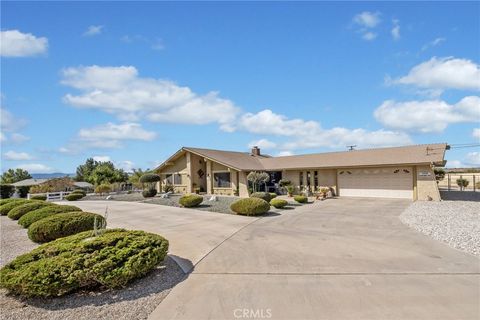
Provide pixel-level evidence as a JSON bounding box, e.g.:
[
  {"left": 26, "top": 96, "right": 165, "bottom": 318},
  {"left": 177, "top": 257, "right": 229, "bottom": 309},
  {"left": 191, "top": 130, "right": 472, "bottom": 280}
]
[{"left": 0, "top": 30, "right": 48, "bottom": 57}]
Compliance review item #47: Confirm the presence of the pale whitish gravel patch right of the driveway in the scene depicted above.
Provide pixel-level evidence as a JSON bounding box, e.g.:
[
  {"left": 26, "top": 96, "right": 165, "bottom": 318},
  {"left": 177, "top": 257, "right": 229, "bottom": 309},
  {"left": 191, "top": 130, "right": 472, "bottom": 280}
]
[{"left": 400, "top": 201, "right": 480, "bottom": 255}]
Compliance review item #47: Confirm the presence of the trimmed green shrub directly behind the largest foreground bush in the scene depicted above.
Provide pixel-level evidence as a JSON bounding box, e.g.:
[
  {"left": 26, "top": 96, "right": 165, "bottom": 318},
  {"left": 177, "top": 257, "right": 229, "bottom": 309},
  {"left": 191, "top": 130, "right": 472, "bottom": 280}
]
[{"left": 28, "top": 212, "right": 105, "bottom": 243}]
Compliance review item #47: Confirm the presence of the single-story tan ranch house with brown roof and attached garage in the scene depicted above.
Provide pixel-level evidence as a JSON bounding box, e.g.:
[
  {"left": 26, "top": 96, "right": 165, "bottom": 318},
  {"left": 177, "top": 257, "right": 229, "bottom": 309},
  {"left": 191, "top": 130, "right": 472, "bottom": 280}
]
[{"left": 155, "top": 143, "right": 448, "bottom": 200}]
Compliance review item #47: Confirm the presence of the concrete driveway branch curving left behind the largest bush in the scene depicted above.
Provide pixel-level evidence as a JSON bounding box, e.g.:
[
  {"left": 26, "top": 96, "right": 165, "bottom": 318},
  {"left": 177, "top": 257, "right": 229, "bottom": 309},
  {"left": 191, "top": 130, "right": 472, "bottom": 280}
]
[{"left": 63, "top": 201, "right": 257, "bottom": 273}]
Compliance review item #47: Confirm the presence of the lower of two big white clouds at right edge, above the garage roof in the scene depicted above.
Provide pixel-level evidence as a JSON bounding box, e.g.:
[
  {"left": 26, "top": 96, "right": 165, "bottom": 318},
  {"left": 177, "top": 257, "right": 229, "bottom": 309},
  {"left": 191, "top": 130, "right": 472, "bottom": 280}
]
[{"left": 374, "top": 96, "right": 480, "bottom": 133}]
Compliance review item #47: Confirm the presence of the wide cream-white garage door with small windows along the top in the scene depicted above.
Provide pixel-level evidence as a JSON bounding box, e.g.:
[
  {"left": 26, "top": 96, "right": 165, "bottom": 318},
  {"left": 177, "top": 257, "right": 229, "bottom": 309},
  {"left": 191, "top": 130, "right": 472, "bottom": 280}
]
[{"left": 338, "top": 167, "right": 413, "bottom": 199}]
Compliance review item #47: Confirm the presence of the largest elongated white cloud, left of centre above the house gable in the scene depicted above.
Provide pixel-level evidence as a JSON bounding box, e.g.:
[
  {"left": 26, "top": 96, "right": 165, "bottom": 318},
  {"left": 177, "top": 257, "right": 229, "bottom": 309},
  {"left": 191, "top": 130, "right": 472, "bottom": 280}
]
[{"left": 62, "top": 66, "right": 239, "bottom": 131}]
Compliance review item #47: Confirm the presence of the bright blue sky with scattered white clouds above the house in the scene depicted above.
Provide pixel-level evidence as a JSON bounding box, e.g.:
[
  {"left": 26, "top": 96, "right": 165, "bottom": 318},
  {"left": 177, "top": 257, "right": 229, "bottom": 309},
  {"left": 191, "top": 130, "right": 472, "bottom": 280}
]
[{"left": 1, "top": 2, "right": 480, "bottom": 173}]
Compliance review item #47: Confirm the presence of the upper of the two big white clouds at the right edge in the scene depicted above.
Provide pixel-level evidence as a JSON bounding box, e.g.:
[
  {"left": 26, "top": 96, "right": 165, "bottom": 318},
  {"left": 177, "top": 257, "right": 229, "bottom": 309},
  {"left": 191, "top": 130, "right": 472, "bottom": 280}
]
[{"left": 391, "top": 57, "right": 480, "bottom": 90}]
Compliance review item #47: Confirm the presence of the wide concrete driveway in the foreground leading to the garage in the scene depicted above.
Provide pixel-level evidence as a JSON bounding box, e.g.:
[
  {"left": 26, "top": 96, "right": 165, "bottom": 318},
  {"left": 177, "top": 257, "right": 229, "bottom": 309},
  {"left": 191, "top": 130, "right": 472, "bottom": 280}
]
[{"left": 149, "top": 198, "right": 480, "bottom": 320}]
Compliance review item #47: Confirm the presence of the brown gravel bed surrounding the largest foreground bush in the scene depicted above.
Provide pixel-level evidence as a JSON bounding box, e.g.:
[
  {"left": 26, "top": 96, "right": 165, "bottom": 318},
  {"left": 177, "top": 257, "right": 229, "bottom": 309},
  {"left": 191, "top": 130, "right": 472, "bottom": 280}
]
[{"left": 0, "top": 216, "right": 185, "bottom": 320}]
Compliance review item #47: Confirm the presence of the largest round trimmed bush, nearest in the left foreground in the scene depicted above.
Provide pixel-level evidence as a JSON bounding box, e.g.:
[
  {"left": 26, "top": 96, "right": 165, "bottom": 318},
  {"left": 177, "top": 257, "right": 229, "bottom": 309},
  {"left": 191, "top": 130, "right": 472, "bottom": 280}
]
[{"left": 0, "top": 229, "right": 168, "bottom": 297}]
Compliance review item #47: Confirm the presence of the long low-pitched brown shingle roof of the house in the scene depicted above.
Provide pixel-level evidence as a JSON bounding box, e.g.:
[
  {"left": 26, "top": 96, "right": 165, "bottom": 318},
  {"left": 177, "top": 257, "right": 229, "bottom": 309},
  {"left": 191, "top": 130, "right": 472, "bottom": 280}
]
[{"left": 157, "top": 143, "right": 447, "bottom": 171}]
